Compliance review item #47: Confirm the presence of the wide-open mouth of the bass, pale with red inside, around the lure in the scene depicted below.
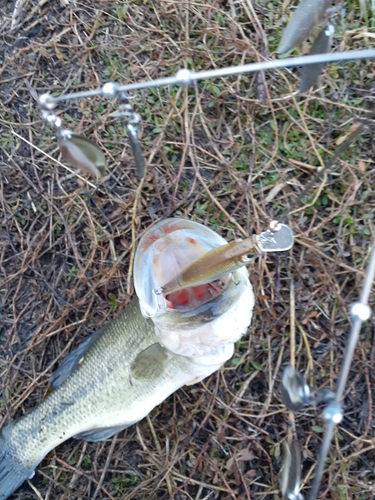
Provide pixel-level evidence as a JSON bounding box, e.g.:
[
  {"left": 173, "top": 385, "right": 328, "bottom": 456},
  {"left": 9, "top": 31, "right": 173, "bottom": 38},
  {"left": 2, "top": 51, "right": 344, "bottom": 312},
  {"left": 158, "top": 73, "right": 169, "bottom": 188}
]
[{"left": 134, "top": 218, "right": 231, "bottom": 317}]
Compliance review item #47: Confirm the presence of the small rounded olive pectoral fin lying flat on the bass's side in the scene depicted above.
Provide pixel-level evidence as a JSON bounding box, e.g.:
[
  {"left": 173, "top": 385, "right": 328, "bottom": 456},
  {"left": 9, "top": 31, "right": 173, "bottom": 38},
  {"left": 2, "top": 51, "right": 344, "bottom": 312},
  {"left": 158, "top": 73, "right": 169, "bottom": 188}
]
[{"left": 130, "top": 342, "right": 168, "bottom": 380}]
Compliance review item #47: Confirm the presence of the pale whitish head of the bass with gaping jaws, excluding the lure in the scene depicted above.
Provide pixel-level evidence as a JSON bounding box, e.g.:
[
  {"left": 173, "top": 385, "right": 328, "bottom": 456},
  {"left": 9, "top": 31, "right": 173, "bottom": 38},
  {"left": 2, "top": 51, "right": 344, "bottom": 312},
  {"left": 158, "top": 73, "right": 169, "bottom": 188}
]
[{"left": 134, "top": 218, "right": 254, "bottom": 363}]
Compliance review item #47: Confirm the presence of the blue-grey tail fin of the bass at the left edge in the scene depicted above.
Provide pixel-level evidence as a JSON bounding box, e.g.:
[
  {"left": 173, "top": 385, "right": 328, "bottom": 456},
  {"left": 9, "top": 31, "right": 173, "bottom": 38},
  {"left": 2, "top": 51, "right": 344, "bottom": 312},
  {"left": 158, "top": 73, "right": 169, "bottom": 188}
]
[{"left": 0, "top": 435, "right": 34, "bottom": 500}]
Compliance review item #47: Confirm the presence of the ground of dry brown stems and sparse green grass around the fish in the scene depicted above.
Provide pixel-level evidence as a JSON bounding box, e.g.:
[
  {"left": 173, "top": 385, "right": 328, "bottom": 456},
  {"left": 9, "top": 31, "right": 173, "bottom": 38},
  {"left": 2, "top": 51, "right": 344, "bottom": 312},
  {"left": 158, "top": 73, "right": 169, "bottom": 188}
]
[{"left": 0, "top": 0, "right": 375, "bottom": 500}]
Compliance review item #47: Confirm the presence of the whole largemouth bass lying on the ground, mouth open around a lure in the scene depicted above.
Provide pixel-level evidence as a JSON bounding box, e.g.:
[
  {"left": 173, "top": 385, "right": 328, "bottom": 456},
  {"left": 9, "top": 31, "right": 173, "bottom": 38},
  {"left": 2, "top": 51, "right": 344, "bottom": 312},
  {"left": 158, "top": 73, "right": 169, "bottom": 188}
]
[{"left": 0, "top": 219, "right": 254, "bottom": 500}]
